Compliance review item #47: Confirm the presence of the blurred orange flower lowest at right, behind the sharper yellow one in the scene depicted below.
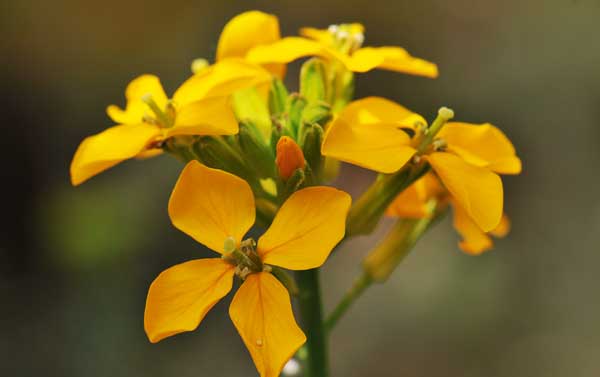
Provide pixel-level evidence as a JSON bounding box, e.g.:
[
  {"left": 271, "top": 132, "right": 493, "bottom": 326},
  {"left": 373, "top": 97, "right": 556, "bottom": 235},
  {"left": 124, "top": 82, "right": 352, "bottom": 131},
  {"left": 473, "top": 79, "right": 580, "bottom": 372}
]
[{"left": 386, "top": 173, "right": 510, "bottom": 255}]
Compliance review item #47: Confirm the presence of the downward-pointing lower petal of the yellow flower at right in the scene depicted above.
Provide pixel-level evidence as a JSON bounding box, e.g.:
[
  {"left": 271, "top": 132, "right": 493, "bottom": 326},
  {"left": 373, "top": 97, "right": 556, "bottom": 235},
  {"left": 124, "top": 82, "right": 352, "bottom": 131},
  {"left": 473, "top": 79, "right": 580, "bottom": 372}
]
[{"left": 427, "top": 152, "right": 503, "bottom": 232}]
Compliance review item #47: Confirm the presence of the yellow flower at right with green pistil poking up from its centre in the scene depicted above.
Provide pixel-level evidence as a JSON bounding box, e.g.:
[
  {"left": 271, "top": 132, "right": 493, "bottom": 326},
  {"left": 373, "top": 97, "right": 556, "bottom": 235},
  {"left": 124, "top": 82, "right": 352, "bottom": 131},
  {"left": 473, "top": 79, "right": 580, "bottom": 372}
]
[{"left": 321, "top": 97, "right": 521, "bottom": 232}]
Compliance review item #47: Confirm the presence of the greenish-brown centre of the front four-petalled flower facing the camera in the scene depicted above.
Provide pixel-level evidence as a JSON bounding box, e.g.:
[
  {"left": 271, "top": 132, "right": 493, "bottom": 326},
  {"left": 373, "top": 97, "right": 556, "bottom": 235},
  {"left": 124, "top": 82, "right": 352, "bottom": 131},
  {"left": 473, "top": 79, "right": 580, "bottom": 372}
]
[{"left": 222, "top": 237, "right": 269, "bottom": 280}]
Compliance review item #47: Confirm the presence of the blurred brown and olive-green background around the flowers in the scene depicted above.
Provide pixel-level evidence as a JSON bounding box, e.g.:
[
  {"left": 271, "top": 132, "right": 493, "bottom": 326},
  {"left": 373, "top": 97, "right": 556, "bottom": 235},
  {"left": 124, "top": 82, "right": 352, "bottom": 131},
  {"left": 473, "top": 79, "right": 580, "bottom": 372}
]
[{"left": 0, "top": 0, "right": 600, "bottom": 377}]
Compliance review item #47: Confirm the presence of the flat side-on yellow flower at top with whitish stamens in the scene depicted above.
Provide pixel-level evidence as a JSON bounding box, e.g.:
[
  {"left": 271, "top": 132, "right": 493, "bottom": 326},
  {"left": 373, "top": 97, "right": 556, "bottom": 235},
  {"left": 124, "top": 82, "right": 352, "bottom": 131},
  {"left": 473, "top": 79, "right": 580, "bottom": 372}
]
[{"left": 246, "top": 24, "right": 438, "bottom": 78}]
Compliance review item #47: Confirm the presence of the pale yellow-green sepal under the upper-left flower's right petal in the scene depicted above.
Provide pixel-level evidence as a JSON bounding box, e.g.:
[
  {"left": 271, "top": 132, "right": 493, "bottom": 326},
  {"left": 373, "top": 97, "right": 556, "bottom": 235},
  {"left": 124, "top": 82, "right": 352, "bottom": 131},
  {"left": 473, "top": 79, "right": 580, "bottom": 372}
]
[{"left": 232, "top": 88, "right": 271, "bottom": 141}]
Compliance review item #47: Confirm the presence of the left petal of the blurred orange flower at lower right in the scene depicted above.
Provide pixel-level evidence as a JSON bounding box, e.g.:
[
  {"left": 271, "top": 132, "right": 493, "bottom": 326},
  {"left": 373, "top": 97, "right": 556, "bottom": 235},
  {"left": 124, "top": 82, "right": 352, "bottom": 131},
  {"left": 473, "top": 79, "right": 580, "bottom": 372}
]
[{"left": 386, "top": 173, "right": 444, "bottom": 219}]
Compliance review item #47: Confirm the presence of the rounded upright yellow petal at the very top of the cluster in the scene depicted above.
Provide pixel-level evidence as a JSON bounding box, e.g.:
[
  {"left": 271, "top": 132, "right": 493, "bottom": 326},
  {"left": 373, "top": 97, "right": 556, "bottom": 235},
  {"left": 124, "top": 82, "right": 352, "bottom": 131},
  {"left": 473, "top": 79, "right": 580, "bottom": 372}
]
[{"left": 217, "top": 10, "right": 281, "bottom": 61}]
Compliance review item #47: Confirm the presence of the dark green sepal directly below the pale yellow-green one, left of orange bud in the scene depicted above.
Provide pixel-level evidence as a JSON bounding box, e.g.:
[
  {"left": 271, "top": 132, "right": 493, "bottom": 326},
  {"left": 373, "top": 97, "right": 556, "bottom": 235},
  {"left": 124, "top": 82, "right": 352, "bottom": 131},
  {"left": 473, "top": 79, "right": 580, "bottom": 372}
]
[{"left": 238, "top": 121, "right": 275, "bottom": 178}]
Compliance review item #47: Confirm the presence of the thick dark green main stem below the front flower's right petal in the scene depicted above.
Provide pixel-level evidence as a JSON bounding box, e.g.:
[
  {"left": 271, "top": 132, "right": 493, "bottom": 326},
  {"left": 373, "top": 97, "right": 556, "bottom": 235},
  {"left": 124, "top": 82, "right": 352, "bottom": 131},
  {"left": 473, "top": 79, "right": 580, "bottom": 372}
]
[{"left": 297, "top": 268, "right": 329, "bottom": 377}]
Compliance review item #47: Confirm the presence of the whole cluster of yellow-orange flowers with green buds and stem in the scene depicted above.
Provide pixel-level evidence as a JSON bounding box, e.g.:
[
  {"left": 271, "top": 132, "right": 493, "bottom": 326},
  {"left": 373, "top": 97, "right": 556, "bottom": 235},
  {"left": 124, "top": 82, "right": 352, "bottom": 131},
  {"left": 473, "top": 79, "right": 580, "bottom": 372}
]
[{"left": 71, "top": 11, "right": 521, "bottom": 377}]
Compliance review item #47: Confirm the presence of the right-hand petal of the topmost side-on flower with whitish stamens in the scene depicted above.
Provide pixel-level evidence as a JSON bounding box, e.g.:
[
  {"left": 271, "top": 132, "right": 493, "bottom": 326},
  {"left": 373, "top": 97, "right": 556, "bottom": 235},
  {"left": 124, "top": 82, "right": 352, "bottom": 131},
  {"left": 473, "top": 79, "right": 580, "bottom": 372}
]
[{"left": 346, "top": 47, "right": 438, "bottom": 78}]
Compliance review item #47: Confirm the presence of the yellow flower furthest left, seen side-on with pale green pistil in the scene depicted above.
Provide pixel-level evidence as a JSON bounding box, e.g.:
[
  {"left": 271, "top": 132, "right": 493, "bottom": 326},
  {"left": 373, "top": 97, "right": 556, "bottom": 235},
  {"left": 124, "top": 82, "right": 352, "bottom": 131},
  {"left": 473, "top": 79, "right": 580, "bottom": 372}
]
[{"left": 71, "top": 58, "right": 270, "bottom": 185}]
